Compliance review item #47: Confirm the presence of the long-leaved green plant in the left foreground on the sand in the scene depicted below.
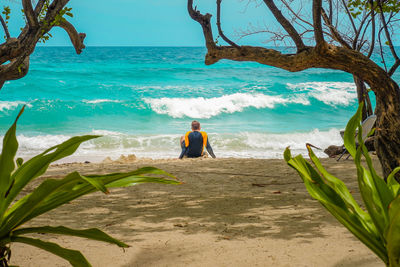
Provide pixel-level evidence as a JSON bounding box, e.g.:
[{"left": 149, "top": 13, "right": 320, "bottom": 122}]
[{"left": 0, "top": 107, "right": 180, "bottom": 267}]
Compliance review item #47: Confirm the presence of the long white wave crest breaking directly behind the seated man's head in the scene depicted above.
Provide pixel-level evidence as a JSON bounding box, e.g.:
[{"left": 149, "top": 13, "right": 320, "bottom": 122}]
[{"left": 144, "top": 93, "right": 310, "bottom": 118}]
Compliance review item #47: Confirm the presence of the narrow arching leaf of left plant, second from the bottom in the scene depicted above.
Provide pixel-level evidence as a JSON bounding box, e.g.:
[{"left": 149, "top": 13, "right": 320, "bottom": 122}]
[{"left": 12, "top": 226, "right": 129, "bottom": 248}]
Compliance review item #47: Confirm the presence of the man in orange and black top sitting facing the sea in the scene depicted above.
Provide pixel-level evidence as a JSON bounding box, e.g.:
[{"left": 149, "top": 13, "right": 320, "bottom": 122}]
[{"left": 179, "top": 121, "right": 215, "bottom": 159}]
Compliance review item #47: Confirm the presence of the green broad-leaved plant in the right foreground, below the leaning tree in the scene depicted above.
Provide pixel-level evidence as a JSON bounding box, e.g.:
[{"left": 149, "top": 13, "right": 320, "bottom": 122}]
[{"left": 284, "top": 105, "right": 400, "bottom": 266}]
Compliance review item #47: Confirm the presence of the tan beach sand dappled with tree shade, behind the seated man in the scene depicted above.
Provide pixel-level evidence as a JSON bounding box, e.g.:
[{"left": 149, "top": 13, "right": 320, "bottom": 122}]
[{"left": 11, "top": 159, "right": 383, "bottom": 267}]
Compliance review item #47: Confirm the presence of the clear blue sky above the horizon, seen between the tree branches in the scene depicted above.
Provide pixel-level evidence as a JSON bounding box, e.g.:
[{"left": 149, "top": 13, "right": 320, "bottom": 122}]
[{"left": 1, "top": 0, "right": 269, "bottom": 46}]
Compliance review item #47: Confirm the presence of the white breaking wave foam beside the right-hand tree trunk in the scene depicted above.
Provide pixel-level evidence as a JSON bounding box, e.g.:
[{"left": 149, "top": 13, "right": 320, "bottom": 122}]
[{"left": 287, "top": 82, "right": 357, "bottom": 106}]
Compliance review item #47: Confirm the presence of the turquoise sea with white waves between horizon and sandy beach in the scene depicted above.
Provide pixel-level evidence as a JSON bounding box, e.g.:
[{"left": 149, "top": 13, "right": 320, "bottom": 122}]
[{"left": 0, "top": 47, "right": 388, "bottom": 161}]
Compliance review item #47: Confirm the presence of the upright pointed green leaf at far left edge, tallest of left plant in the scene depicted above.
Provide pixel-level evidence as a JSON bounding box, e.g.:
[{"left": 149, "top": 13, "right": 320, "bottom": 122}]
[{"left": 0, "top": 106, "right": 25, "bottom": 201}]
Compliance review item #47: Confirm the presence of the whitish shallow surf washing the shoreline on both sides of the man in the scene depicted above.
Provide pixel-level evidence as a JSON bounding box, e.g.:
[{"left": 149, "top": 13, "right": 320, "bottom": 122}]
[{"left": 0, "top": 129, "right": 343, "bottom": 162}]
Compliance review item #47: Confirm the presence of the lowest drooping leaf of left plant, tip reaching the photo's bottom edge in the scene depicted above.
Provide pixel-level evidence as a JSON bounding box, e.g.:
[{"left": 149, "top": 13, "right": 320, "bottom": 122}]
[{"left": 11, "top": 236, "right": 91, "bottom": 267}]
